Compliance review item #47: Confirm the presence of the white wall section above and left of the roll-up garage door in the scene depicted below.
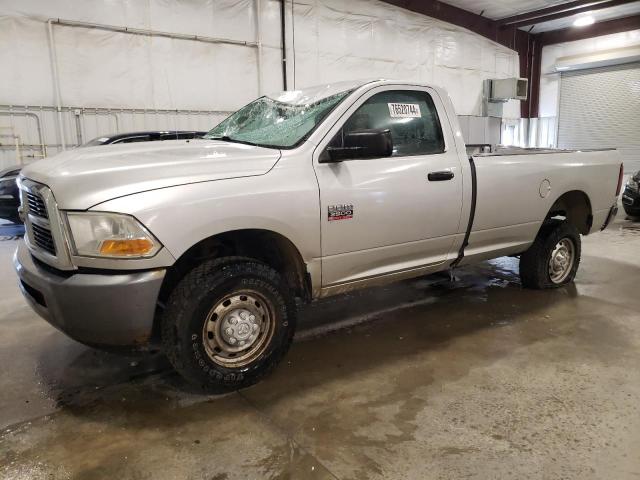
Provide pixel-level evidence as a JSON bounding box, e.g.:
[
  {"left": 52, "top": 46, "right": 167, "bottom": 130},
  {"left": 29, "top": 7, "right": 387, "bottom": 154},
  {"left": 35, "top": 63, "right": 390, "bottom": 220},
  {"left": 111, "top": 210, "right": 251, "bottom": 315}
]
[{"left": 539, "top": 30, "right": 640, "bottom": 117}]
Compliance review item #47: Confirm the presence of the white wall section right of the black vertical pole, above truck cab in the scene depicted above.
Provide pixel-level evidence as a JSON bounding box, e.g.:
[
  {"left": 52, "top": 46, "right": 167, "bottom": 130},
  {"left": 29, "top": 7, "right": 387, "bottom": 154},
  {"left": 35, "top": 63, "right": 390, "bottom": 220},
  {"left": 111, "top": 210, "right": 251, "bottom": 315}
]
[{"left": 289, "top": 0, "right": 520, "bottom": 117}]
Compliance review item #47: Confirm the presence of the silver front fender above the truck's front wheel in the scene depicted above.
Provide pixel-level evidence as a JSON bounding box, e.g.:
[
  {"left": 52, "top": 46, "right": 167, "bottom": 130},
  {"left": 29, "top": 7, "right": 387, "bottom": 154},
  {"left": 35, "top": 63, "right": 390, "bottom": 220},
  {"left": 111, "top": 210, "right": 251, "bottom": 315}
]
[{"left": 92, "top": 171, "right": 320, "bottom": 268}]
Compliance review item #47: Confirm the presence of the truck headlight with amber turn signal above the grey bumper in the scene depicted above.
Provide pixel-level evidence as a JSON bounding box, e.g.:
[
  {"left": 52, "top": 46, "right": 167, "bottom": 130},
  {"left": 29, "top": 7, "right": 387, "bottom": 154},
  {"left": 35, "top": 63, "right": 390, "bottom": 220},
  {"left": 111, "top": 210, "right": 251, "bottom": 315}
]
[{"left": 66, "top": 212, "right": 162, "bottom": 258}]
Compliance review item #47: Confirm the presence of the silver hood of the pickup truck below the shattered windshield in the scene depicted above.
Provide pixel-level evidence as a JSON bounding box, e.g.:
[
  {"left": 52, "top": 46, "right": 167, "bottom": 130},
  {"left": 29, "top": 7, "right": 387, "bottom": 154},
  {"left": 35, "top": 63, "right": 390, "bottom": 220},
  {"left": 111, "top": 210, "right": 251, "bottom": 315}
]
[{"left": 22, "top": 140, "right": 280, "bottom": 210}]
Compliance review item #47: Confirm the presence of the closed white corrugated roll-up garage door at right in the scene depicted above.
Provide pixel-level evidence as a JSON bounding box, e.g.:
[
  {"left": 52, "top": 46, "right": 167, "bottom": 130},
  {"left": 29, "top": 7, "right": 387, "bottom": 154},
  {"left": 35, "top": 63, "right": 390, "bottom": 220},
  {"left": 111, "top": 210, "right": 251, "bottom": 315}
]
[{"left": 558, "top": 63, "right": 640, "bottom": 172}]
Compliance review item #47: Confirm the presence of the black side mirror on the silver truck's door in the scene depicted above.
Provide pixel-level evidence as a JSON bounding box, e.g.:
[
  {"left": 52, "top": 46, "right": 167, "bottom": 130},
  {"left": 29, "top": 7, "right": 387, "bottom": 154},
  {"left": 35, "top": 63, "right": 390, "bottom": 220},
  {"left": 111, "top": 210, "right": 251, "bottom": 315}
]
[{"left": 322, "top": 128, "right": 393, "bottom": 163}]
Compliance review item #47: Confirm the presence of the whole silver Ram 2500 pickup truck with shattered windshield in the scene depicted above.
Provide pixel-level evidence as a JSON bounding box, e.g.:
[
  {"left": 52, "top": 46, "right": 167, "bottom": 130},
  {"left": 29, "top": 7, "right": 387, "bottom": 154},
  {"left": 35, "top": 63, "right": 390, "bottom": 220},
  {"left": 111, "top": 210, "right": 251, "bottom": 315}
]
[{"left": 14, "top": 80, "right": 622, "bottom": 391}]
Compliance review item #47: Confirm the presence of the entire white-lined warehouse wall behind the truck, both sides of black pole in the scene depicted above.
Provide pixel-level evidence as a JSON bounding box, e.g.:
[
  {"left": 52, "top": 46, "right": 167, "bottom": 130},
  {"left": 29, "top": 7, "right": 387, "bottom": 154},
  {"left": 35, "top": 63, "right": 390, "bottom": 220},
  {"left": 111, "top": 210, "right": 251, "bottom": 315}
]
[{"left": 0, "top": 0, "right": 519, "bottom": 167}]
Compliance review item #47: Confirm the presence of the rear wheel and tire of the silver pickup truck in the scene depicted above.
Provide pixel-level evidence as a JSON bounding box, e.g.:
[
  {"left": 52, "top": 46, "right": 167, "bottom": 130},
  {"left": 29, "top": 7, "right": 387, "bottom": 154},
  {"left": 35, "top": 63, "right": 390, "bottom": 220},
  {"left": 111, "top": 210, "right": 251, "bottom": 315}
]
[{"left": 520, "top": 220, "right": 581, "bottom": 290}]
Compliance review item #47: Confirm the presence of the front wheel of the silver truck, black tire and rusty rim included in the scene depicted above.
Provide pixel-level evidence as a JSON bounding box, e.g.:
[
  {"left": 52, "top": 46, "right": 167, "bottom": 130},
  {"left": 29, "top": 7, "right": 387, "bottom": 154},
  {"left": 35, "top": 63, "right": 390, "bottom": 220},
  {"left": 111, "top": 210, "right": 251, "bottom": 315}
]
[{"left": 161, "top": 258, "right": 296, "bottom": 393}]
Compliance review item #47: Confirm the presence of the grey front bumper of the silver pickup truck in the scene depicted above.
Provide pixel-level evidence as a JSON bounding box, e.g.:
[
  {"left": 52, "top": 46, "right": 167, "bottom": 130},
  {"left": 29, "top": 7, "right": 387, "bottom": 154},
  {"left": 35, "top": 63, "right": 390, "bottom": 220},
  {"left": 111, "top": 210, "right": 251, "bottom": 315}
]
[{"left": 13, "top": 242, "right": 165, "bottom": 347}]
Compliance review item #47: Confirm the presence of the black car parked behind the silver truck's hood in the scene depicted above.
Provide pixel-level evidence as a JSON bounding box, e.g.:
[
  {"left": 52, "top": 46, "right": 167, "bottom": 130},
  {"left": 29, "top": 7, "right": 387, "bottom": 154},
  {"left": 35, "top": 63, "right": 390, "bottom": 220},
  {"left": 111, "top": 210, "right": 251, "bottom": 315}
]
[{"left": 0, "top": 130, "right": 207, "bottom": 223}]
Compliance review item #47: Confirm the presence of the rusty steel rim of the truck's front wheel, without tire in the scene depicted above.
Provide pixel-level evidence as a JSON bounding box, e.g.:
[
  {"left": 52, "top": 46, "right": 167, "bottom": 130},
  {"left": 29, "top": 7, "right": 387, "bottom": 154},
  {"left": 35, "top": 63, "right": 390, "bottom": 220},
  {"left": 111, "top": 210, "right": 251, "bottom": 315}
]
[{"left": 202, "top": 291, "right": 274, "bottom": 368}]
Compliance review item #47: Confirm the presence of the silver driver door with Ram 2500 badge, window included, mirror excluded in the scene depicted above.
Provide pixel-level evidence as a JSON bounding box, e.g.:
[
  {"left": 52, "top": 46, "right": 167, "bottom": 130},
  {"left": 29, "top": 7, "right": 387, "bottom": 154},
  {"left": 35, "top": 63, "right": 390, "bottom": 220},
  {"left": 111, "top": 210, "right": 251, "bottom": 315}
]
[{"left": 314, "top": 86, "right": 462, "bottom": 288}]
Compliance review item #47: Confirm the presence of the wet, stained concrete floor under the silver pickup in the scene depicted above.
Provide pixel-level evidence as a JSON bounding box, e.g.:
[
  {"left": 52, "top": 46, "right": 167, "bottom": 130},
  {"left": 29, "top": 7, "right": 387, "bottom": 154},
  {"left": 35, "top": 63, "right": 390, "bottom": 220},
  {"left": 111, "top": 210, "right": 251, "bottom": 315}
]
[{"left": 0, "top": 215, "right": 640, "bottom": 480}]
